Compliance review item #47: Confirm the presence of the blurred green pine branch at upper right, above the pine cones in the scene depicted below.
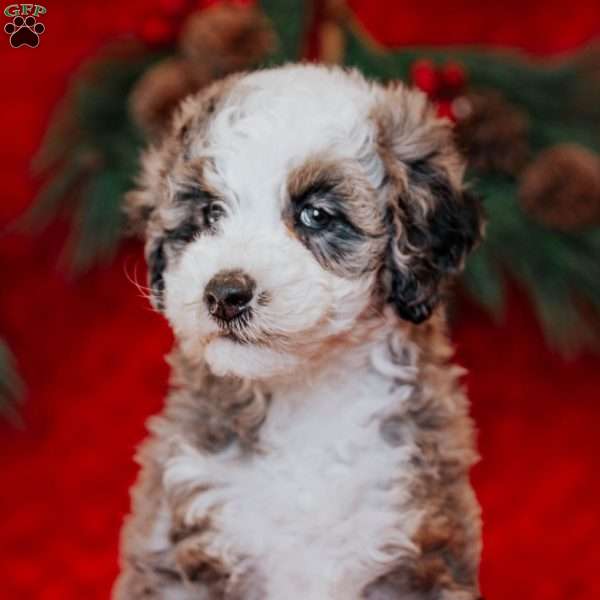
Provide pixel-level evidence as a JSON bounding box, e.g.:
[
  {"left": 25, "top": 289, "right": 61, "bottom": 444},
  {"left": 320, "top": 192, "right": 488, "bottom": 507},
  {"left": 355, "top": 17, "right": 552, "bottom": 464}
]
[{"left": 345, "top": 33, "right": 600, "bottom": 151}]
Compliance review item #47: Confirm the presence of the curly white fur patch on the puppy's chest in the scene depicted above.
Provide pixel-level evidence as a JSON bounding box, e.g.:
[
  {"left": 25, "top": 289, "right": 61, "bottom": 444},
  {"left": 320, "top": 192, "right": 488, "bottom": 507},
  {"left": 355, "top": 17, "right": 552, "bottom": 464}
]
[{"left": 165, "top": 350, "right": 420, "bottom": 600}]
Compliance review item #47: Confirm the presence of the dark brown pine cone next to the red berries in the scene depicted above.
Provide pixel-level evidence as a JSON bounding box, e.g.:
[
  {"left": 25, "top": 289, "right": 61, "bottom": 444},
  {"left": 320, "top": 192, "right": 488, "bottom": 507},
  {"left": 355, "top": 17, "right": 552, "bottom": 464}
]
[{"left": 452, "top": 90, "right": 529, "bottom": 175}]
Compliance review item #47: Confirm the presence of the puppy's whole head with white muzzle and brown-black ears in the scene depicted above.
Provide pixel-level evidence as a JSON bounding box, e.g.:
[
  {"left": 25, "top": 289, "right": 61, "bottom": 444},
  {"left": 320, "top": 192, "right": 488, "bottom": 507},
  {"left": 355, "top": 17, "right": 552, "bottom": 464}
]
[{"left": 128, "top": 66, "right": 479, "bottom": 378}]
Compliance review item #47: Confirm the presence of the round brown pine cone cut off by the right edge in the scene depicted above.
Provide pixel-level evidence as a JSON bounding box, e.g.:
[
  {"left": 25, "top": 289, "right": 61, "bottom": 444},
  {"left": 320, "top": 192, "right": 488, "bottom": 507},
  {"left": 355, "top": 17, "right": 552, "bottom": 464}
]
[{"left": 519, "top": 144, "right": 600, "bottom": 231}]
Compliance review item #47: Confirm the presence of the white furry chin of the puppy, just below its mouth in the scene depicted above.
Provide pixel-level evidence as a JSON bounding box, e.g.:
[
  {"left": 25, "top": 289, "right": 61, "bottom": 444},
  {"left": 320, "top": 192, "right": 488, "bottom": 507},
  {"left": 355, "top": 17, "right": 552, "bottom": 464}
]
[{"left": 204, "top": 338, "right": 300, "bottom": 379}]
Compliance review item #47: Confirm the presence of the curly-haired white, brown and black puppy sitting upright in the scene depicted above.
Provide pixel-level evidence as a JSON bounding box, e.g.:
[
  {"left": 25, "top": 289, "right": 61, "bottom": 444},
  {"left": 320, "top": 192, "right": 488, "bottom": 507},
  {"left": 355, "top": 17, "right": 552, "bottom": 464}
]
[{"left": 113, "top": 65, "right": 482, "bottom": 600}]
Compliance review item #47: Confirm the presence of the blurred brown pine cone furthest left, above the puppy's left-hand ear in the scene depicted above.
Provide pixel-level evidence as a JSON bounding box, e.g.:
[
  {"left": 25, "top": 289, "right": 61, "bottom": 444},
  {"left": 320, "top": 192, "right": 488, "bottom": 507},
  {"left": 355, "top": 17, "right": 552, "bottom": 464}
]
[{"left": 129, "top": 59, "right": 211, "bottom": 136}]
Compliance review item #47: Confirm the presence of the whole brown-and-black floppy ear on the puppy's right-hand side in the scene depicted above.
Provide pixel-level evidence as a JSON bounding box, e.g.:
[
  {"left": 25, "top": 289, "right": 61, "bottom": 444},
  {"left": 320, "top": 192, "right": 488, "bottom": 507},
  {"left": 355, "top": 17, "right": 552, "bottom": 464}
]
[{"left": 378, "top": 86, "right": 483, "bottom": 323}]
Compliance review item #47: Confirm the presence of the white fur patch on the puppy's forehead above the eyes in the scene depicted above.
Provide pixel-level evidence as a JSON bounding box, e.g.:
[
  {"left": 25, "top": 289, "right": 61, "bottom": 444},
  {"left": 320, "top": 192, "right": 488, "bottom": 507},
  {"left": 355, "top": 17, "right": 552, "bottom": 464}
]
[{"left": 191, "top": 65, "right": 383, "bottom": 211}]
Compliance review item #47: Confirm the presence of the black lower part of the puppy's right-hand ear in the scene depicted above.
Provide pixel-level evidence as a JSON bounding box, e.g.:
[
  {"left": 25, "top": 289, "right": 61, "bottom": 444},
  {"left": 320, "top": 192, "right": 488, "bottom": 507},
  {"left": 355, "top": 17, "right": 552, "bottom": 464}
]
[{"left": 387, "top": 160, "right": 482, "bottom": 323}]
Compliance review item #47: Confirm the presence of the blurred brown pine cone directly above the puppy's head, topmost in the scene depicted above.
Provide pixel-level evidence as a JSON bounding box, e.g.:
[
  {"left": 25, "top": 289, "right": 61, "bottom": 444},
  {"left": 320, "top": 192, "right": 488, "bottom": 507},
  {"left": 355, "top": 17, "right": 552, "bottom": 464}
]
[{"left": 179, "top": 3, "right": 275, "bottom": 76}]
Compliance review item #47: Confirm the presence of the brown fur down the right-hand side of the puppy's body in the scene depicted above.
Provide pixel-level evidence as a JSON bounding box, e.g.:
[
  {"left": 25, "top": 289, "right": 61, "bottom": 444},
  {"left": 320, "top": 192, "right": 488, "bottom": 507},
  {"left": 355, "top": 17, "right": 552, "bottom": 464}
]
[{"left": 365, "top": 311, "right": 480, "bottom": 600}]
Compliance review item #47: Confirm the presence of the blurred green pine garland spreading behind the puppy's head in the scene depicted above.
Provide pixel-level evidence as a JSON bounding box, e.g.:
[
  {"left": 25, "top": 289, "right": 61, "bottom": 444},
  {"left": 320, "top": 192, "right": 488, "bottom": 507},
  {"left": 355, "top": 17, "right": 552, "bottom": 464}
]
[{"left": 28, "top": 0, "right": 600, "bottom": 347}]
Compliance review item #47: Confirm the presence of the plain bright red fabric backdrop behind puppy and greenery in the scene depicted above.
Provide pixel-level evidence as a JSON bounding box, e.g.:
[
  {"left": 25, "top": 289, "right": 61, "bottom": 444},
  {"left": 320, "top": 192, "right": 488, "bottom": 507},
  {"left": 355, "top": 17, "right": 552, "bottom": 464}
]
[{"left": 0, "top": 0, "right": 600, "bottom": 600}]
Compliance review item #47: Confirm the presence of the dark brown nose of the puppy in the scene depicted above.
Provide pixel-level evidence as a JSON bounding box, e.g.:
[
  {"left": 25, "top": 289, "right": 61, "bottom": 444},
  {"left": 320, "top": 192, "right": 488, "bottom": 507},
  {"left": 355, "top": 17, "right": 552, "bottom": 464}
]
[{"left": 204, "top": 271, "right": 255, "bottom": 321}]
